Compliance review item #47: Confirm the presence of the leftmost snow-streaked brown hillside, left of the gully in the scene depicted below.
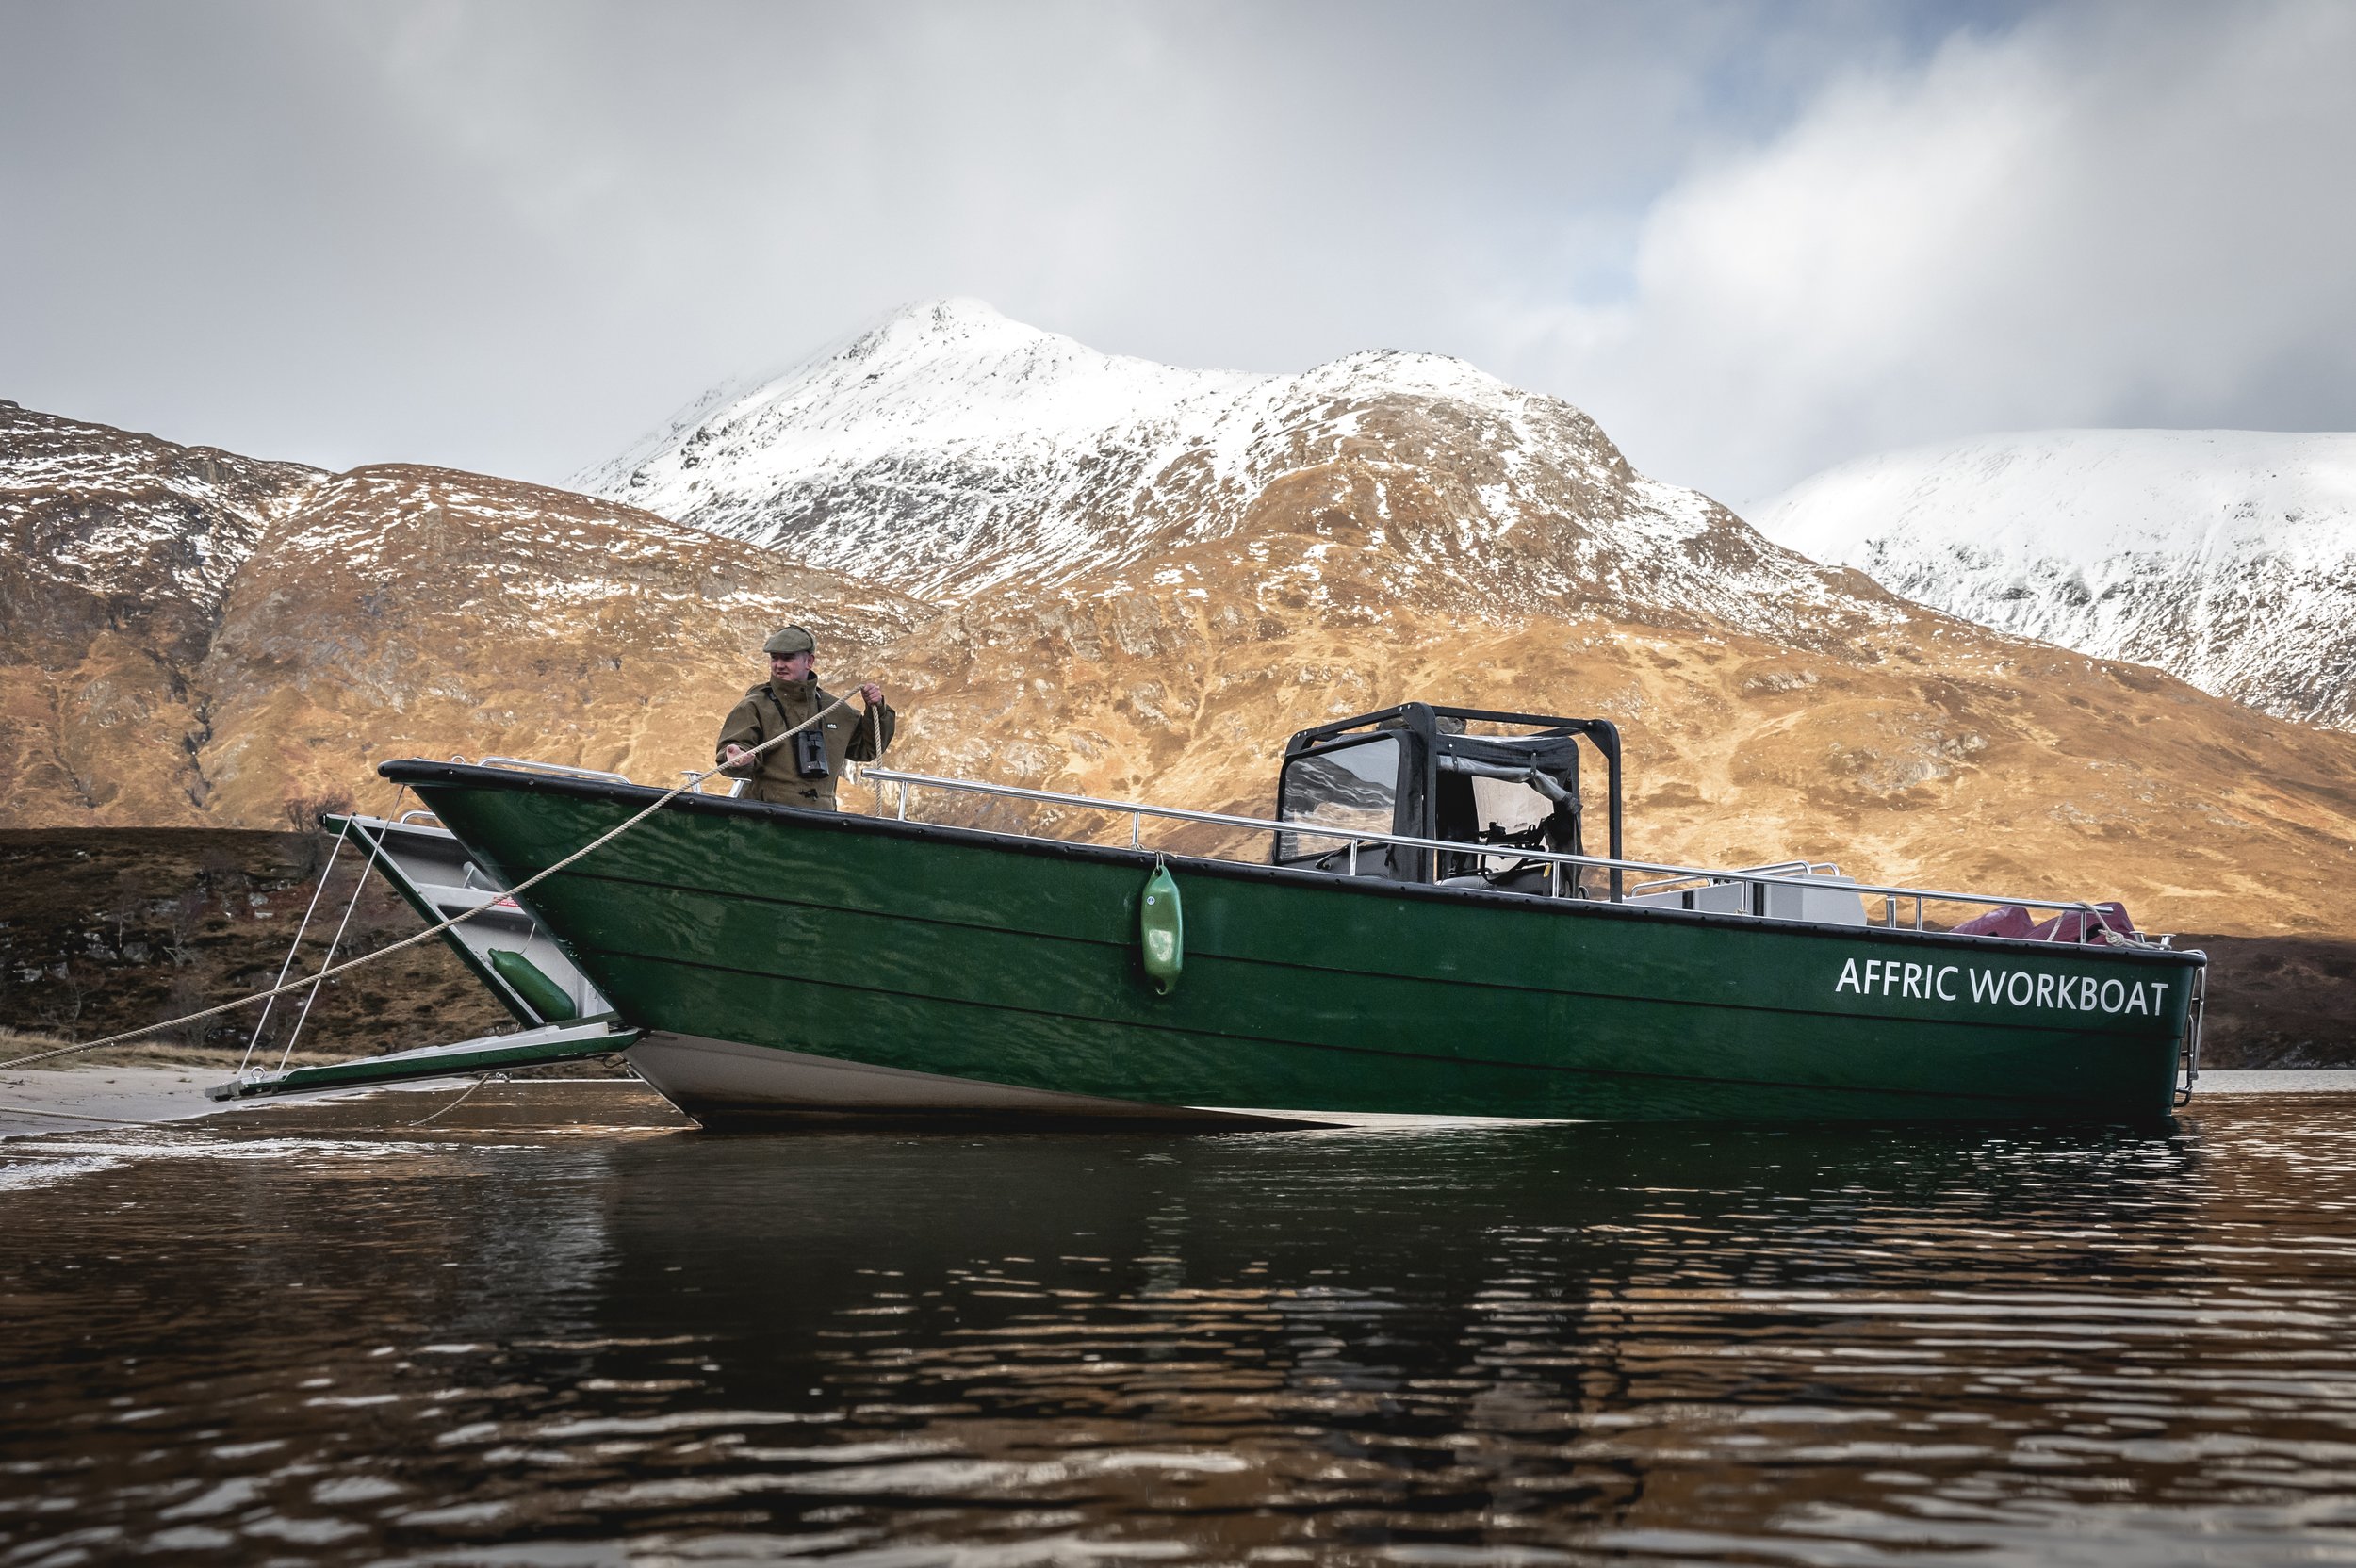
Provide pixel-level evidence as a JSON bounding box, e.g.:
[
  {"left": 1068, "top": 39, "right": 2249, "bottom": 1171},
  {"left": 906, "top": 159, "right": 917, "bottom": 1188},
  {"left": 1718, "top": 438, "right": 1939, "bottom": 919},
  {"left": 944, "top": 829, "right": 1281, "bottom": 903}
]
[{"left": 0, "top": 402, "right": 323, "bottom": 824}]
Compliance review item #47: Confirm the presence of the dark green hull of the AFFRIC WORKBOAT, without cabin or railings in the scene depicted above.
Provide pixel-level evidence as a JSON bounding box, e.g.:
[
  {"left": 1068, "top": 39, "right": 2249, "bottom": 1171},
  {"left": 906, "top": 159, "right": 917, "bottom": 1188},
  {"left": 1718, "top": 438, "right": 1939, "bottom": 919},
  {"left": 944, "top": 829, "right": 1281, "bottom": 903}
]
[{"left": 384, "top": 763, "right": 2201, "bottom": 1125}]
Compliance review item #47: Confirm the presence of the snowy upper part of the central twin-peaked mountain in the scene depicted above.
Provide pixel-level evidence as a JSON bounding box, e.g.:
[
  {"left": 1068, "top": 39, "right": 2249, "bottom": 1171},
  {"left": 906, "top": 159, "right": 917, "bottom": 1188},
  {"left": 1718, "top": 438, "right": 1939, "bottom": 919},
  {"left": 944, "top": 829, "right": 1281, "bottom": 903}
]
[{"left": 573, "top": 299, "right": 1857, "bottom": 631}]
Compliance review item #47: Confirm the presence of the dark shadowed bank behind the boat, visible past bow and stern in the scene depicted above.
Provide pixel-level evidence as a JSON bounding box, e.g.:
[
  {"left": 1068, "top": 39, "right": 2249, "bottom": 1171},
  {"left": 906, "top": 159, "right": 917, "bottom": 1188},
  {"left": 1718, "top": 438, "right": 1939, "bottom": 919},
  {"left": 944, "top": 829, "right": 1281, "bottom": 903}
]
[{"left": 0, "top": 828, "right": 2356, "bottom": 1076}]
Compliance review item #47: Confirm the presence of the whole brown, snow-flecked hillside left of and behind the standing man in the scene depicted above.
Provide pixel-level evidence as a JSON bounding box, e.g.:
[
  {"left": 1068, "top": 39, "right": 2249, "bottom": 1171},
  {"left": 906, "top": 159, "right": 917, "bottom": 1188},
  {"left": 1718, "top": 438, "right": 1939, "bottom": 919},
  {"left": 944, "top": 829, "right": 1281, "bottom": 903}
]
[{"left": 0, "top": 405, "right": 931, "bottom": 828}]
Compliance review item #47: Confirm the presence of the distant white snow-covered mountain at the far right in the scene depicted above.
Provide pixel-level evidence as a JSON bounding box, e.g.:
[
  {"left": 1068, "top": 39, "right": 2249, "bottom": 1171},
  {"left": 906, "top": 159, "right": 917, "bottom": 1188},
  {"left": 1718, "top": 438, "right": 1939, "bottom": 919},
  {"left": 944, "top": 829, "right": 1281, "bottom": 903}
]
[{"left": 1751, "top": 431, "right": 2356, "bottom": 730}]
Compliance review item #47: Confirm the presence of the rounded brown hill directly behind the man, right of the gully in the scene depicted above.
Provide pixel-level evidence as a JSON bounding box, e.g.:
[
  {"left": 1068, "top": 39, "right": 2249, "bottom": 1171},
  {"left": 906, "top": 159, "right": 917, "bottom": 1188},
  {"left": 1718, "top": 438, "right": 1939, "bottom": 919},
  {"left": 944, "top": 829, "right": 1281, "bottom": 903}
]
[{"left": 196, "top": 464, "right": 931, "bottom": 826}]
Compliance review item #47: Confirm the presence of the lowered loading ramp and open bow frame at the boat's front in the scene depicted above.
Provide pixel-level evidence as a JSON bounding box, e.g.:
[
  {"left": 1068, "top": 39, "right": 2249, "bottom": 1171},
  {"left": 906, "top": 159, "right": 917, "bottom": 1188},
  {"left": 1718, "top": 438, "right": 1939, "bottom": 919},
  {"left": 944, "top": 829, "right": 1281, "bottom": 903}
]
[{"left": 205, "top": 812, "right": 639, "bottom": 1100}]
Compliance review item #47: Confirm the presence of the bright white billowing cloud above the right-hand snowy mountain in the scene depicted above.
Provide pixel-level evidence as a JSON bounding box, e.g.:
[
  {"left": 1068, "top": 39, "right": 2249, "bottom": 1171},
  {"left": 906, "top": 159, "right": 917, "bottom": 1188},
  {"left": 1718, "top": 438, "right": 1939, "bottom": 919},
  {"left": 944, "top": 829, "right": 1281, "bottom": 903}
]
[{"left": 1498, "top": 5, "right": 2356, "bottom": 497}]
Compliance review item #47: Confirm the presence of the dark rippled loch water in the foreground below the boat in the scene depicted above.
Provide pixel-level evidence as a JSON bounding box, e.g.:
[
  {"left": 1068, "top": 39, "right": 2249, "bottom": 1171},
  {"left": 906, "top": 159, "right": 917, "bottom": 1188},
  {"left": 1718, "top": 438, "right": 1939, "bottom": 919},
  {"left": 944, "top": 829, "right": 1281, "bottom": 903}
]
[{"left": 0, "top": 1083, "right": 2356, "bottom": 1568}]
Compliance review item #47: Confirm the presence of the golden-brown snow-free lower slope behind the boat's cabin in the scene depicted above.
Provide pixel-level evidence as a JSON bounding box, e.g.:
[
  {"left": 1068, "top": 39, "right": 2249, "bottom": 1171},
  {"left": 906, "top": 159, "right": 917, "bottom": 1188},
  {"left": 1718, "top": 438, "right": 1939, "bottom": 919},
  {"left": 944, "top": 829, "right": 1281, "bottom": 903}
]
[{"left": 884, "top": 513, "right": 2356, "bottom": 932}]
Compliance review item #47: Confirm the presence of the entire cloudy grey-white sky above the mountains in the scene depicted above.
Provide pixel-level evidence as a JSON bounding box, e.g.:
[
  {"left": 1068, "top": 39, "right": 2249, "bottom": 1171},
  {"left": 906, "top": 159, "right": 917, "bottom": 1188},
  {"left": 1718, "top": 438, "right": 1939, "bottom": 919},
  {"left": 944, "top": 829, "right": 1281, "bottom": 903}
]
[{"left": 0, "top": 0, "right": 2356, "bottom": 501}]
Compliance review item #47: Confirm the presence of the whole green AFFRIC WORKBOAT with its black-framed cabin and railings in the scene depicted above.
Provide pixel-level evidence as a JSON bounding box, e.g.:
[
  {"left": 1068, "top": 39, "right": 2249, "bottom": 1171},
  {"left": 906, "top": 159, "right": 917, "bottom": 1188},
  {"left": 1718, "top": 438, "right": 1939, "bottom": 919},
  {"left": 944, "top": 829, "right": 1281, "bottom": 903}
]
[{"left": 294, "top": 704, "right": 2205, "bottom": 1128}]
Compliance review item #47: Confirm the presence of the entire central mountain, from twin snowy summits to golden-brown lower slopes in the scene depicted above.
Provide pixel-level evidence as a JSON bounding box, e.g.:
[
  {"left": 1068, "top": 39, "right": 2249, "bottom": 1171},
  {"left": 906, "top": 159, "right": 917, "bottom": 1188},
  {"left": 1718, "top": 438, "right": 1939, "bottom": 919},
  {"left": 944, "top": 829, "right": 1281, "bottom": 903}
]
[{"left": 556, "top": 302, "right": 2356, "bottom": 930}]
